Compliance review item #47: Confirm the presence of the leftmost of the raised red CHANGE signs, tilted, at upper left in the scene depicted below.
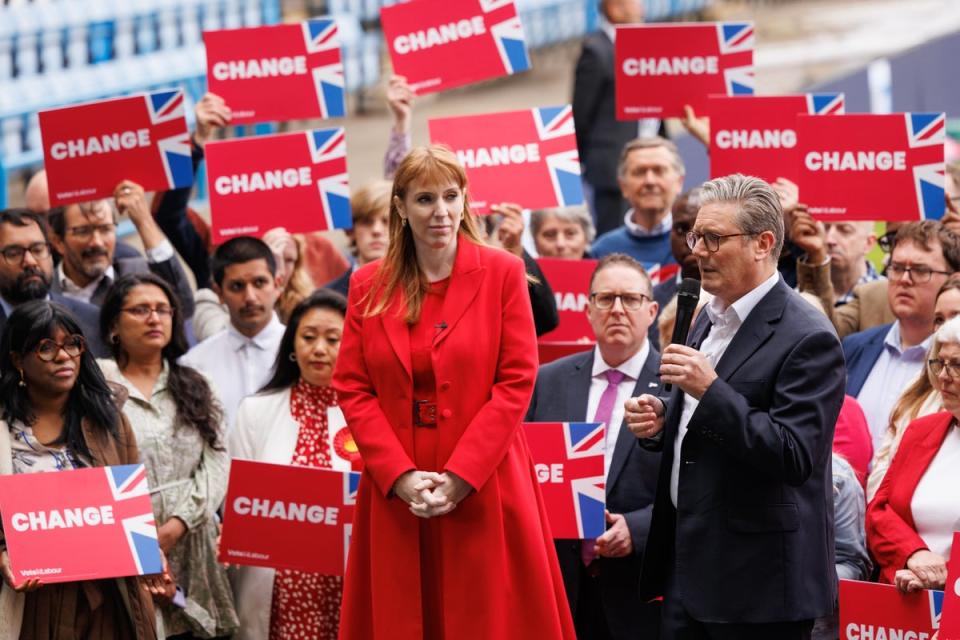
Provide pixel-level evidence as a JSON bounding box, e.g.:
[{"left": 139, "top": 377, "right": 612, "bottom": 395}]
[{"left": 40, "top": 90, "right": 193, "bottom": 207}]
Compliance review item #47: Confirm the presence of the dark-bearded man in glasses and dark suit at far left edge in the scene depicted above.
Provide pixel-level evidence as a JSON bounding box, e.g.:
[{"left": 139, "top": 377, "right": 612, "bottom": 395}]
[{"left": 0, "top": 209, "right": 109, "bottom": 357}]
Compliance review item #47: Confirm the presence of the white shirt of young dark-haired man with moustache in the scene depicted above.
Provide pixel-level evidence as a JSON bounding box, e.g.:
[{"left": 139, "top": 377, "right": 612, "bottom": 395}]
[{"left": 180, "top": 314, "right": 284, "bottom": 432}]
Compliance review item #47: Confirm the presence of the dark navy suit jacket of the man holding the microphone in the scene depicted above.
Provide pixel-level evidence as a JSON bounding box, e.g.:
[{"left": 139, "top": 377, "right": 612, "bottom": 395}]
[{"left": 641, "top": 278, "right": 845, "bottom": 623}]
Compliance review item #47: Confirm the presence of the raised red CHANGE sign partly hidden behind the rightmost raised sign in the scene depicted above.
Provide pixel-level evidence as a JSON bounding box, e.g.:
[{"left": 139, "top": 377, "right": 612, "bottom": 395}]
[{"left": 704, "top": 93, "right": 843, "bottom": 182}]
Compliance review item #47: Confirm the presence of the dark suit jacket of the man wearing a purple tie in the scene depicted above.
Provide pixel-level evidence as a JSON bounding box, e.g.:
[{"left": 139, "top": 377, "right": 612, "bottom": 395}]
[{"left": 526, "top": 348, "right": 660, "bottom": 638}]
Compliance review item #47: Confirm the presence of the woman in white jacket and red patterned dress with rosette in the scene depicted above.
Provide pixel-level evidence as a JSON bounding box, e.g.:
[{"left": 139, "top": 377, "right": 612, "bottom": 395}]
[{"left": 229, "top": 289, "right": 359, "bottom": 640}]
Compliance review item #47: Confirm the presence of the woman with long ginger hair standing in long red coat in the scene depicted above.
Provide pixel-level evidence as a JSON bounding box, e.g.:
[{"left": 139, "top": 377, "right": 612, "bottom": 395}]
[{"left": 334, "top": 147, "right": 574, "bottom": 640}]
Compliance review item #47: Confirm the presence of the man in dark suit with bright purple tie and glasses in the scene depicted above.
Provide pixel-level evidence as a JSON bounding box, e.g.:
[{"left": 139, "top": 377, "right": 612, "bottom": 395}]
[{"left": 527, "top": 254, "right": 660, "bottom": 640}]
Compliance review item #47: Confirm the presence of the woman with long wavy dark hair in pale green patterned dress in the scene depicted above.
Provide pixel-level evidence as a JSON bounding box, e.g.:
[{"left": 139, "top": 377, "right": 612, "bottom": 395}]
[{"left": 99, "top": 273, "right": 237, "bottom": 638}]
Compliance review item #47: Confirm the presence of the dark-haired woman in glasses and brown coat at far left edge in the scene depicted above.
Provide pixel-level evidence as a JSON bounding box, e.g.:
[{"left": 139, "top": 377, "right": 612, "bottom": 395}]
[{"left": 0, "top": 300, "right": 162, "bottom": 640}]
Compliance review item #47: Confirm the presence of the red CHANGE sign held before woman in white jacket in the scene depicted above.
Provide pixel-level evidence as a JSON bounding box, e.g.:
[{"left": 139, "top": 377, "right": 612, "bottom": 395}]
[{"left": 220, "top": 460, "right": 360, "bottom": 576}]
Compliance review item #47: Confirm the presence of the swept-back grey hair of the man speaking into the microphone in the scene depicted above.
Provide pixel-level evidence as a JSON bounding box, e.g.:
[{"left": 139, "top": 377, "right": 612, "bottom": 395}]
[{"left": 700, "top": 173, "right": 784, "bottom": 262}]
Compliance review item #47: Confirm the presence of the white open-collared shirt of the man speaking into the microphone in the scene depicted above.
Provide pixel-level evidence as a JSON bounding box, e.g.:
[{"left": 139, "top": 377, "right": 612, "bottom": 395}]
[{"left": 670, "top": 271, "right": 780, "bottom": 507}]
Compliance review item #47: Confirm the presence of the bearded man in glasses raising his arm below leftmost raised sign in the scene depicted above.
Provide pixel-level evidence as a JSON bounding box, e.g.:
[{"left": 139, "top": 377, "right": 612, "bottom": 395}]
[{"left": 47, "top": 180, "right": 193, "bottom": 317}]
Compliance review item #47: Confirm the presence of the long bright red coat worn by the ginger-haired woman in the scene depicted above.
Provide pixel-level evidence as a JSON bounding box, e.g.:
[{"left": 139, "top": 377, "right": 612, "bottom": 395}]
[{"left": 334, "top": 240, "right": 575, "bottom": 640}]
